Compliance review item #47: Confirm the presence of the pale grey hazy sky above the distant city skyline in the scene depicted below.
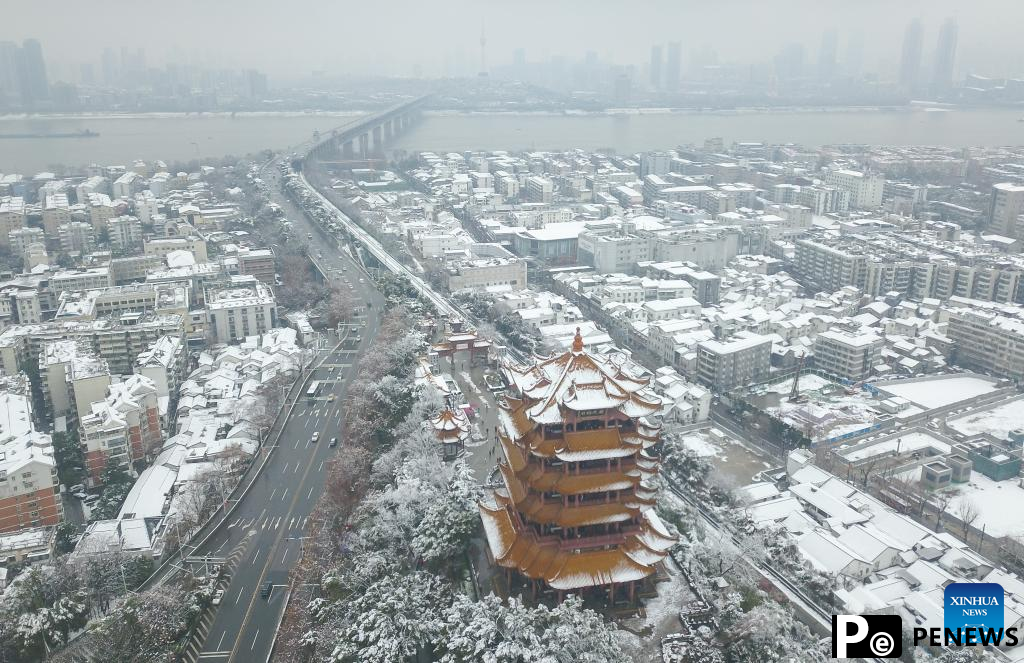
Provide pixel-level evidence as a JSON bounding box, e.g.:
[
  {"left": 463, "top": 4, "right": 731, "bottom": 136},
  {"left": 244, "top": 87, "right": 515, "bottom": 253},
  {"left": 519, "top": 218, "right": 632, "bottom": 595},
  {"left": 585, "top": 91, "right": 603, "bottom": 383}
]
[{"left": 6, "top": 0, "right": 1024, "bottom": 80}]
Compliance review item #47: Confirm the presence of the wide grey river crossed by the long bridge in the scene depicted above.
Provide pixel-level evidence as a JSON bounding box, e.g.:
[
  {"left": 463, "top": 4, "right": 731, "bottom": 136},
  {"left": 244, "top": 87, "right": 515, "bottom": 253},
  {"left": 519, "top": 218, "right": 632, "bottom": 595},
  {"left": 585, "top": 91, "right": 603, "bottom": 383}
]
[{"left": 0, "top": 109, "right": 1024, "bottom": 173}]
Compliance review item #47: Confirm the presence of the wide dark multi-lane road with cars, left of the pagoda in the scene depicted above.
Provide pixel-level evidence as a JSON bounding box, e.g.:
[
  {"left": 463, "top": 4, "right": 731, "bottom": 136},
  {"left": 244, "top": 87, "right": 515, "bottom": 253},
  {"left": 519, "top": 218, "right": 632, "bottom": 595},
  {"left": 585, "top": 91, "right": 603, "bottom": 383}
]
[{"left": 186, "top": 155, "right": 383, "bottom": 663}]
